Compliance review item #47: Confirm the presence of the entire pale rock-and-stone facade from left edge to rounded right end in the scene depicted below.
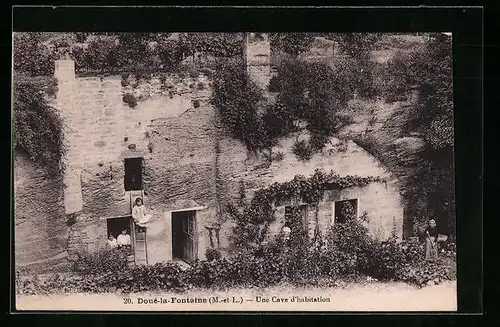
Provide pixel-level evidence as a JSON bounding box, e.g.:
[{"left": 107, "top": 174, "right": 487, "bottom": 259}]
[{"left": 15, "top": 61, "right": 402, "bottom": 272}]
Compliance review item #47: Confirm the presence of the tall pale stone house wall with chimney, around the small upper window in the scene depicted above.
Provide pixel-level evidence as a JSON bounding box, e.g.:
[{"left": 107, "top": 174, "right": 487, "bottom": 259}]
[{"left": 56, "top": 61, "right": 215, "bottom": 257}]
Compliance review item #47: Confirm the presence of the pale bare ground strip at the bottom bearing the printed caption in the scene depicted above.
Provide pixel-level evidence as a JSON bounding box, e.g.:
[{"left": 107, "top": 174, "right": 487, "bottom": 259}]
[{"left": 16, "top": 282, "right": 457, "bottom": 311}]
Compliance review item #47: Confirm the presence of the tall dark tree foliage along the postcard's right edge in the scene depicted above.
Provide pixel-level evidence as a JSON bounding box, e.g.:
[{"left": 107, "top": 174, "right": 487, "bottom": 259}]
[{"left": 400, "top": 33, "right": 455, "bottom": 234}]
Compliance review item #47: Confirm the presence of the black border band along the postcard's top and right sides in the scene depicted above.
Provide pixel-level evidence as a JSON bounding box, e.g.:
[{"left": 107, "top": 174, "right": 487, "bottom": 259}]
[{"left": 7, "top": 6, "right": 483, "bottom": 323}]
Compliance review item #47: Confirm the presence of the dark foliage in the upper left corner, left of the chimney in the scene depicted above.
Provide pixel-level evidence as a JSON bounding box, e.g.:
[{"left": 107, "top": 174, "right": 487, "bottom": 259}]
[{"left": 13, "top": 33, "right": 65, "bottom": 173}]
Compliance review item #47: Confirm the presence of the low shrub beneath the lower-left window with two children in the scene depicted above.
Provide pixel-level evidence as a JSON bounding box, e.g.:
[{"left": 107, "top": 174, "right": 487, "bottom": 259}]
[{"left": 72, "top": 249, "right": 127, "bottom": 275}]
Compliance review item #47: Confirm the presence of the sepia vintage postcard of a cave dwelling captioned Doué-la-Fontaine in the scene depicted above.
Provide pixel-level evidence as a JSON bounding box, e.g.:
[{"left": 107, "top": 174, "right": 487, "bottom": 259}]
[{"left": 12, "top": 31, "right": 457, "bottom": 312}]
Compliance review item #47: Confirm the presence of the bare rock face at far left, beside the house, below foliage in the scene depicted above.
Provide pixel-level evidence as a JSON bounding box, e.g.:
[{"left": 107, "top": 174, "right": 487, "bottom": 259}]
[{"left": 14, "top": 153, "right": 68, "bottom": 270}]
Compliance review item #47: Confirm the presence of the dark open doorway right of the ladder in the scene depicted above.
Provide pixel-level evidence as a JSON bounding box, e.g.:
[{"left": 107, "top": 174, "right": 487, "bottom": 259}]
[{"left": 172, "top": 211, "right": 198, "bottom": 262}]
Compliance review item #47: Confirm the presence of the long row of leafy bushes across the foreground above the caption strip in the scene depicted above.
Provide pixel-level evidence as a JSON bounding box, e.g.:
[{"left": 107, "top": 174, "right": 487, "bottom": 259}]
[{"left": 16, "top": 229, "right": 456, "bottom": 295}]
